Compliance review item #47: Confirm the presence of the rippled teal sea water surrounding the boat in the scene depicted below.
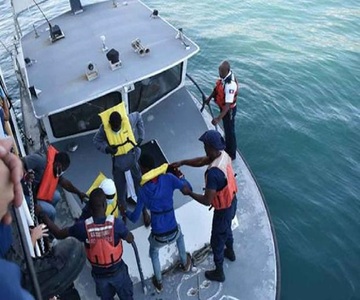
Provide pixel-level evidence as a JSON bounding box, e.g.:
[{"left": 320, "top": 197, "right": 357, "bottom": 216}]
[{"left": 0, "top": 0, "right": 360, "bottom": 300}]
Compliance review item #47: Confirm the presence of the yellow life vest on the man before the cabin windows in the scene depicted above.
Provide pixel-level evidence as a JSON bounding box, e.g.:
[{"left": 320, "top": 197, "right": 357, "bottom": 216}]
[{"left": 99, "top": 102, "right": 136, "bottom": 156}]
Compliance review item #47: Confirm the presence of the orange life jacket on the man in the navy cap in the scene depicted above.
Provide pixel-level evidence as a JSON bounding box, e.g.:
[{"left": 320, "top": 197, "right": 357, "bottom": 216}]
[{"left": 205, "top": 151, "right": 237, "bottom": 210}]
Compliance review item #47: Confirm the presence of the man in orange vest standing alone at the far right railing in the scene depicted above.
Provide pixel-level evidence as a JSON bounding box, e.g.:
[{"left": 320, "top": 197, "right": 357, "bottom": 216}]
[{"left": 205, "top": 61, "right": 238, "bottom": 160}]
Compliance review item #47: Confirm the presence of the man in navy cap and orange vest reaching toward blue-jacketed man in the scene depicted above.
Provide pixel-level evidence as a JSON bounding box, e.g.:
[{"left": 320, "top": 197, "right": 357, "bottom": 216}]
[{"left": 172, "top": 130, "right": 237, "bottom": 282}]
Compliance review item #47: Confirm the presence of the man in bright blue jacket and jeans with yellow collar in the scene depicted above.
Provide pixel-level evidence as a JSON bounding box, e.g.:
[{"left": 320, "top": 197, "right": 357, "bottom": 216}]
[{"left": 125, "top": 154, "right": 191, "bottom": 293}]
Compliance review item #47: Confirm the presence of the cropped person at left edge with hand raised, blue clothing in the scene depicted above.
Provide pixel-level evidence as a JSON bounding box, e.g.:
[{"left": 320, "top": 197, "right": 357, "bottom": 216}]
[{"left": 0, "top": 138, "right": 34, "bottom": 300}]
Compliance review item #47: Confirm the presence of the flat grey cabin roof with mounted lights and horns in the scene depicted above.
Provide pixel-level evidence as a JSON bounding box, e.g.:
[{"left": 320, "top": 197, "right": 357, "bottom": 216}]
[{"left": 22, "top": 1, "right": 199, "bottom": 117}]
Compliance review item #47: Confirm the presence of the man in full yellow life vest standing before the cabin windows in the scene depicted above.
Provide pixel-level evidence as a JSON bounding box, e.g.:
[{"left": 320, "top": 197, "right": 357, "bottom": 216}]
[{"left": 93, "top": 102, "right": 150, "bottom": 226}]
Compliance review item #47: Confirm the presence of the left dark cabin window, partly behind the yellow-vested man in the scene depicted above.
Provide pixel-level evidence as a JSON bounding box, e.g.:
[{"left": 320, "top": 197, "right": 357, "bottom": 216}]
[{"left": 49, "top": 92, "right": 122, "bottom": 138}]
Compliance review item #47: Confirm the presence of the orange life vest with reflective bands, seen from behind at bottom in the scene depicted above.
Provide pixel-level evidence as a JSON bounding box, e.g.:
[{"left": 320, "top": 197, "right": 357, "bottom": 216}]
[{"left": 85, "top": 215, "right": 123, "bottom": 268}]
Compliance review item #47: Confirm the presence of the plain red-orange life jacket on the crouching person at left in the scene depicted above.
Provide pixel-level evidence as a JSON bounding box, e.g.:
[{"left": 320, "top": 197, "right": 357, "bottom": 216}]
[{"left": 36, "top": 145, "right": 59, "bottom": 202}]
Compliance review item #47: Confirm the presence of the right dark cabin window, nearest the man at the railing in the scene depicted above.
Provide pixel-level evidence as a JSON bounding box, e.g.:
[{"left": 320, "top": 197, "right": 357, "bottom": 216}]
[{"left": 128, "top": 63, "right": 182, "bottom": 112}]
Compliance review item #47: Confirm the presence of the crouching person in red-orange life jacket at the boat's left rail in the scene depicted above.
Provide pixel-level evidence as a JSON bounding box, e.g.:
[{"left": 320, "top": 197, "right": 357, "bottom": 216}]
[{"left": 22, "top": 145, "right": 87, "bottom": 220}]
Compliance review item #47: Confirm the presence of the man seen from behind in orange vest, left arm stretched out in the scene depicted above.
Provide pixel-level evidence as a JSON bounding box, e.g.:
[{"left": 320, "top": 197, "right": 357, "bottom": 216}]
[{"left": 36, "top": 188, "right": 134, "bottom": 300}]
